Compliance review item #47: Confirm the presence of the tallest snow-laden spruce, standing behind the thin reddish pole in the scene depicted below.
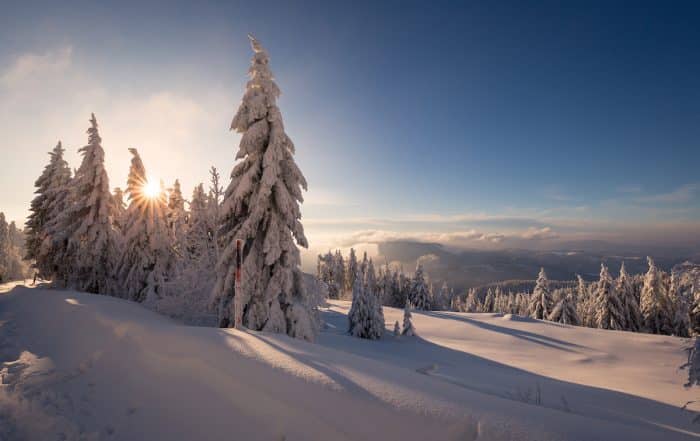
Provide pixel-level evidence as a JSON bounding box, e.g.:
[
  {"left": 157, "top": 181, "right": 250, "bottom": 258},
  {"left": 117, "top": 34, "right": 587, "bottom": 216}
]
[{"left": 213, "top": 37, "right": 318, "bottom": 340}]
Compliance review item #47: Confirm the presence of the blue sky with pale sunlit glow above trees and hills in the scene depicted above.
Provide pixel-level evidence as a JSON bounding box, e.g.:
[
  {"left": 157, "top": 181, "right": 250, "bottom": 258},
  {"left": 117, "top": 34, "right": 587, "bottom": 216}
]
[{"left": 0, "top": 1, "right": 700, "bottom": 264}]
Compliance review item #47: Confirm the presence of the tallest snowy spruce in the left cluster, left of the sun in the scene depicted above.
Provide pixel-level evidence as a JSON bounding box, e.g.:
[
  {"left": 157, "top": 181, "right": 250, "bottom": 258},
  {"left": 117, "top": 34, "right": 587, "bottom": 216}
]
[{"left": 53, "top": 114, "right": 119, "bottom": 294}]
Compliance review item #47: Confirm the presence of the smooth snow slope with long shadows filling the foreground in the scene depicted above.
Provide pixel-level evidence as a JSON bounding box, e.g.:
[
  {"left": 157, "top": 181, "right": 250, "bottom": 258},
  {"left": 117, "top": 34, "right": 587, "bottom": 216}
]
[{"left": 0, "top": 286, "right": 700, "bottom": 441}]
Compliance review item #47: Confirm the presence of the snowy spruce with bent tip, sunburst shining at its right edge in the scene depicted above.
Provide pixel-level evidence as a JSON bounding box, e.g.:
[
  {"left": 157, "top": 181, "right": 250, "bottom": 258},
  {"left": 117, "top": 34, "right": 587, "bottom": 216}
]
[{"left": 118, "top": 148, "right": 173, "bottom": 302}]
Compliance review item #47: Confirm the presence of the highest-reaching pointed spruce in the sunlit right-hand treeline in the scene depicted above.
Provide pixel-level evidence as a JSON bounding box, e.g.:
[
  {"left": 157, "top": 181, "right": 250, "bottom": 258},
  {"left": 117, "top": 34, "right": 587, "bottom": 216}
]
[{"left": 639, "top": 257, "right": 673, "bottom": 335}]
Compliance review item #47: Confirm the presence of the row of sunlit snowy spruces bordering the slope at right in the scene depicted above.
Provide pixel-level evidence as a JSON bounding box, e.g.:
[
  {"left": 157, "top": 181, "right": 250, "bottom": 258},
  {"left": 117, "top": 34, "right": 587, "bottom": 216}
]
[{"left": 452, "top": 258, "right": 700, "bottom": 337}]
